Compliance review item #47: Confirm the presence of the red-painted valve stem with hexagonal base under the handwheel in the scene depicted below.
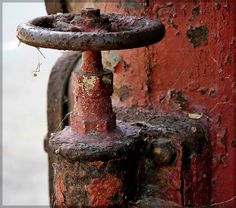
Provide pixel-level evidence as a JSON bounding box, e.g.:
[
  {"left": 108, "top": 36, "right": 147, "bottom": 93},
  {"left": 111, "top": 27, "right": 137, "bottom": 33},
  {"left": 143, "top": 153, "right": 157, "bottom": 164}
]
[{"left": 70, "top": 51, "right": 116, "bottom": 134}]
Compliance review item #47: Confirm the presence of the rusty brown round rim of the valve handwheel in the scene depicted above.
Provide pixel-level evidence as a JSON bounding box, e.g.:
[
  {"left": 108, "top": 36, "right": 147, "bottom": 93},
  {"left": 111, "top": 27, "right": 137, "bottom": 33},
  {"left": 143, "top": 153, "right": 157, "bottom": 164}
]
[{"left": 17, "top": 14, "right": 165, "bottom": 51}]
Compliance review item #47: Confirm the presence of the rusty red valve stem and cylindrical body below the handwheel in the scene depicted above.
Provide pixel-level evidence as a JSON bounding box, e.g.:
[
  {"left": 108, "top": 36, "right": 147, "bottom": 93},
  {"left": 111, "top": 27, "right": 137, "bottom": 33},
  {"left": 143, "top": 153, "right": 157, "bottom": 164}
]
[{"left": 49, "top": 48, "right": 140, "bottom": 207}]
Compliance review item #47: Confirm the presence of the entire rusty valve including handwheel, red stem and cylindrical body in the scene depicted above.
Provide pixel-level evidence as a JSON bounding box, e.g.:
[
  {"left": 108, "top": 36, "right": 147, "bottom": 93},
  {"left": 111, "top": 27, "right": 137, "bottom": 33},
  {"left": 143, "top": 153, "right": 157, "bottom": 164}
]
[{"left": 17, "top": 9, "right": 165, "bottom": 207}]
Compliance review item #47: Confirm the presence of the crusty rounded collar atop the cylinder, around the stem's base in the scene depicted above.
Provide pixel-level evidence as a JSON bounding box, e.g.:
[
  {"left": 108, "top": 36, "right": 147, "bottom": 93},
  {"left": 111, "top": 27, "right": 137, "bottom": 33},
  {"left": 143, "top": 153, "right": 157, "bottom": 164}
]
[{"left": 49, "top": 122, "right": 139, "bottom": 161}]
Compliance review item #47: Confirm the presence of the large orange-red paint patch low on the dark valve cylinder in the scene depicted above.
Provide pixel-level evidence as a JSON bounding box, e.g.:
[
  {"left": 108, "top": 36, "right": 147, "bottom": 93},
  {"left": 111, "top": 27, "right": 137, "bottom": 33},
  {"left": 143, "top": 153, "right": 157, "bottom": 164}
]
[{"left": 87, "top": 176, "right": 122, "bottom": 207}]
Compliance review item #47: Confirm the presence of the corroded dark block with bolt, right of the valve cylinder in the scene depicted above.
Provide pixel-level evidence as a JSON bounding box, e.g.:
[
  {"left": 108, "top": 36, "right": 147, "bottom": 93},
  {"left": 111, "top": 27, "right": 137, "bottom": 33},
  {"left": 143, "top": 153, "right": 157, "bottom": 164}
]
[{"left": 114, "top": 108, "right": 212, "bottom": 207}]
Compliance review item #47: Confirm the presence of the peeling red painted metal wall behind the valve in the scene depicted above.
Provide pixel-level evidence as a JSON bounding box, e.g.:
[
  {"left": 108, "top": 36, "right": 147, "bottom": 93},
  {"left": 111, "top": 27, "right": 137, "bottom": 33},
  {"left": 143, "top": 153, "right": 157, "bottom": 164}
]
[{"left": 71, "top": 0, "right": 236, "bottom": 206}]
